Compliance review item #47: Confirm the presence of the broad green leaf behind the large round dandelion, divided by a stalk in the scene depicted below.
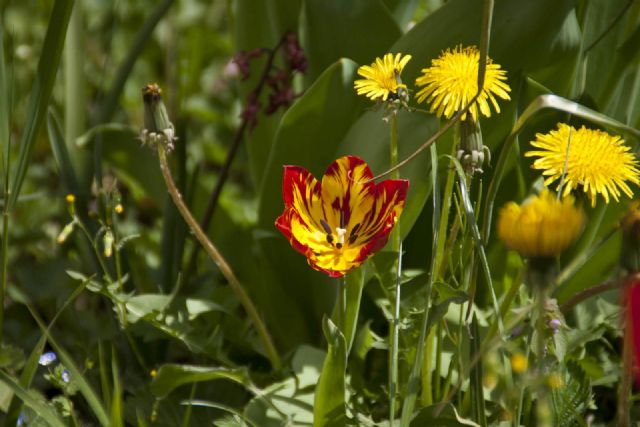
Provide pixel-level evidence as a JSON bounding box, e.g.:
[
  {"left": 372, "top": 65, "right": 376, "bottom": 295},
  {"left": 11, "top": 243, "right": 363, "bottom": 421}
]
[{"left": 391, "top": 0, "right": 580, "bottom": 81}]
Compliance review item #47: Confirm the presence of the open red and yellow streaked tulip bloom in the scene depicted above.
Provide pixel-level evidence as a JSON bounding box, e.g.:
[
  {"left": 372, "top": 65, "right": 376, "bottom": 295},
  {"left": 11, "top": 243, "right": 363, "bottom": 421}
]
[{"left": 276, "top": 156, "right": 409, "bottom": 277}]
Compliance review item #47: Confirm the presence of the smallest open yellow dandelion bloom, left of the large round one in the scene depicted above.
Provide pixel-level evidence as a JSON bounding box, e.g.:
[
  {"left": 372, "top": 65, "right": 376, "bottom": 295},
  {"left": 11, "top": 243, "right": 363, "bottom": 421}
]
[{"left": 353, "top": 53, "right": 411, "bottom": 101}]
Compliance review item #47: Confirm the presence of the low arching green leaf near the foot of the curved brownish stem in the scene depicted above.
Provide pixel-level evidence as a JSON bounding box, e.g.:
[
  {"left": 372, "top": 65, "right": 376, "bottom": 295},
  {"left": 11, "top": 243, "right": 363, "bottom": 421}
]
[{"left": 151, "top": 364, "right": 251, "bottom": 399}]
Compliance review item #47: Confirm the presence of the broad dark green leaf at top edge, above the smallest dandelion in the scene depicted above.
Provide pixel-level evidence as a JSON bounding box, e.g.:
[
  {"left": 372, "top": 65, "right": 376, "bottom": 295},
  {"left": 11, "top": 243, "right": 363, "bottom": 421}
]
[{"left": 304, "top": 0, "right": 401, "bottom": 81}]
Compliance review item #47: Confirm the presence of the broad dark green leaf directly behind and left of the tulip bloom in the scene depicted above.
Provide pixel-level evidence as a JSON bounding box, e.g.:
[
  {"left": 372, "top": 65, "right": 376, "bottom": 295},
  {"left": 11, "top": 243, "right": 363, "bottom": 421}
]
[{"left": 257, "top": 59, "right": 366, "bottom": 348}]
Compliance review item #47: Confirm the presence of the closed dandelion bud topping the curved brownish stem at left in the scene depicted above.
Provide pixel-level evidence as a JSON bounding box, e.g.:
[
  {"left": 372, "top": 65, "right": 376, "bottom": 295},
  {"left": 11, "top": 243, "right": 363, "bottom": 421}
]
[{"left": 140, "top": 83, "right": 176, "bottom": 149}]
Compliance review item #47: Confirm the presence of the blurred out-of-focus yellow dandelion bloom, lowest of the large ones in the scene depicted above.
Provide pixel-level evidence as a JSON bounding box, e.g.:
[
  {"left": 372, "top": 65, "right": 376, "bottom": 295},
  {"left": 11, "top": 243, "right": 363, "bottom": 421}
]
[{"left": 498, "top": 189, "right": 585, "bottom": 258}]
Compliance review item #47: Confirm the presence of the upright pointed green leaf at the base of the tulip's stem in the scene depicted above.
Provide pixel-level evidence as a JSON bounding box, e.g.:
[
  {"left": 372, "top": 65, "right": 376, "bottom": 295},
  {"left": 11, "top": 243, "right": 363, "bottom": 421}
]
[{"left": 313, "top": 317, "right": 347, "bottom": 427}]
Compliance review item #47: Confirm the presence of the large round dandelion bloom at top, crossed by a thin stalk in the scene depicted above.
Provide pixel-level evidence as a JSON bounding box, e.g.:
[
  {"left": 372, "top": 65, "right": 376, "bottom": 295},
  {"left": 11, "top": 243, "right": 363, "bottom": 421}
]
[{"left": 416, "top": 46, "right": 511, "bottom": 120}]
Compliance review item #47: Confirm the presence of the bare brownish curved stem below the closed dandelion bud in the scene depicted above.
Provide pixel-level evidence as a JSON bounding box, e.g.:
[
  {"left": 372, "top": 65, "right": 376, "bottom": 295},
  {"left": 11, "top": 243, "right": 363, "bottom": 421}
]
[{"left": 158, "top": 143, "right": 282, "bottom": 369}]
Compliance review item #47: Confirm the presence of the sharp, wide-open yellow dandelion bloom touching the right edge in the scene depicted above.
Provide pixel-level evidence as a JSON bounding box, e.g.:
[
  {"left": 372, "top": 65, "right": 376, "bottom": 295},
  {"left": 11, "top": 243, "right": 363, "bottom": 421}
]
[{"left": 524, "top": 123, "right": 640, "bottom": 206}]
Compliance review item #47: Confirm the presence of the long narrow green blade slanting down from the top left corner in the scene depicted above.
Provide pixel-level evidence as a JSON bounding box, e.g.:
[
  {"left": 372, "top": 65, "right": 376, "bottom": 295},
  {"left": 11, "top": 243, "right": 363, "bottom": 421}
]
[{"left": 8, "top": 0, "right": 73, "bottom": 211}]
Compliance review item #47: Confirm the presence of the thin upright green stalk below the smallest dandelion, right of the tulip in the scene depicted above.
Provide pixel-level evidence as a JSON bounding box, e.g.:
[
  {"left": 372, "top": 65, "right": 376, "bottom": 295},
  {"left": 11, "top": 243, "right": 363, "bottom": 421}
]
[{"left": 389, "top": 111, "right": 402, "bottom": 426}]
